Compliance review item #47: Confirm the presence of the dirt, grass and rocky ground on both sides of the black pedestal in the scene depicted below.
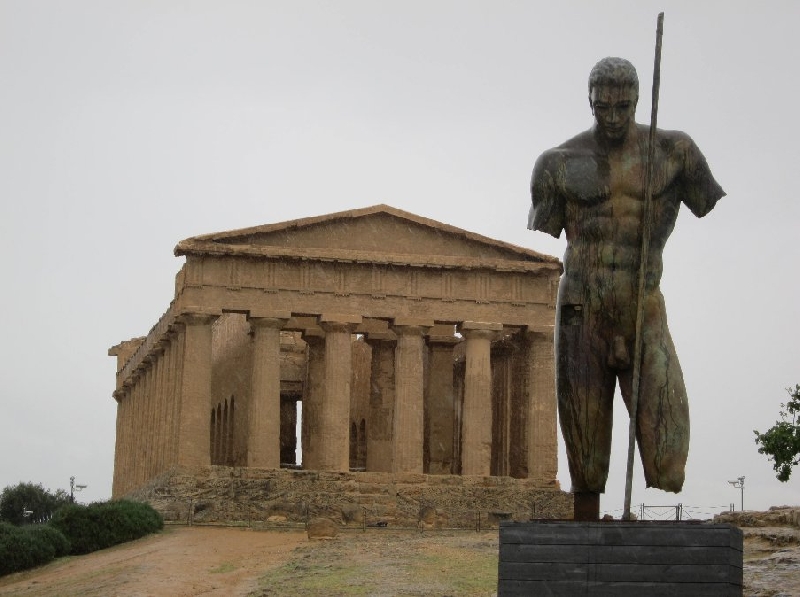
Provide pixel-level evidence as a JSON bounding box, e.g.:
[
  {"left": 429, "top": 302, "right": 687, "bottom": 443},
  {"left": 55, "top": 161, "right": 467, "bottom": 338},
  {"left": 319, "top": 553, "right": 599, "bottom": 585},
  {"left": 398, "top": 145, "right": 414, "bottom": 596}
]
[{"left": 0, "top": 509, "right": 800, "bottom": 597}]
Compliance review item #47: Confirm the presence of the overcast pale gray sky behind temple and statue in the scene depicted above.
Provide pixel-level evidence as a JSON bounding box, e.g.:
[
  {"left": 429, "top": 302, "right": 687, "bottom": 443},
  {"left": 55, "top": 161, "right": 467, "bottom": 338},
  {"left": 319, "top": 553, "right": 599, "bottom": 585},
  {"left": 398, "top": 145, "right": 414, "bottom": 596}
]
[{"left": 0, "top": 0, "right": 800, "bottom": 512}]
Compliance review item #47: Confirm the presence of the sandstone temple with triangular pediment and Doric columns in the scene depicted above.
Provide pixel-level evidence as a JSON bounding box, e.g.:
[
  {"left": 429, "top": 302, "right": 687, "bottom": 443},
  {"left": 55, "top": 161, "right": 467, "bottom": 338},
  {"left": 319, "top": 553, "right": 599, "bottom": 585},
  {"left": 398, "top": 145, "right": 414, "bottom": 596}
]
[{"left": 109, "top": 205, "right": 572, "bottom": 524}]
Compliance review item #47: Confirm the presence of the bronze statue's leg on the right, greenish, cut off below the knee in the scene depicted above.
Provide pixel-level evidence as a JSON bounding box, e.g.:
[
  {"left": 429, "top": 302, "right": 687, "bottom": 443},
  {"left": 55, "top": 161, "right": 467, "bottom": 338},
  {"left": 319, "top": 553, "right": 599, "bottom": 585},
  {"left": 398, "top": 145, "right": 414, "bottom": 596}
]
[{"left": 620, "top": 293, "right": 689, "bottom": 493}]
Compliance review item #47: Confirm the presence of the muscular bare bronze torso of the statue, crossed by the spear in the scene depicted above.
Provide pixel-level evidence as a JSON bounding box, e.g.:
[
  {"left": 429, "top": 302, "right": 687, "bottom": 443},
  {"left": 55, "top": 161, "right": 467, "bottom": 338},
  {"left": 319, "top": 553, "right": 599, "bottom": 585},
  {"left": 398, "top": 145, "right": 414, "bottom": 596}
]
[{"left": 554, "top": 127, "right": 683, "bottom": 309}]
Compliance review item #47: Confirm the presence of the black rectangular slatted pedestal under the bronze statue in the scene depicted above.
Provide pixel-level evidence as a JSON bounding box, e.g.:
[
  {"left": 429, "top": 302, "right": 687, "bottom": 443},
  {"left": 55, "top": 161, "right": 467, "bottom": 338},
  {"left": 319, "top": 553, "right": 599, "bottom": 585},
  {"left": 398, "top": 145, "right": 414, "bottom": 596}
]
[{"left": 497, "top": 520, "right": 742, "bottom": 597}]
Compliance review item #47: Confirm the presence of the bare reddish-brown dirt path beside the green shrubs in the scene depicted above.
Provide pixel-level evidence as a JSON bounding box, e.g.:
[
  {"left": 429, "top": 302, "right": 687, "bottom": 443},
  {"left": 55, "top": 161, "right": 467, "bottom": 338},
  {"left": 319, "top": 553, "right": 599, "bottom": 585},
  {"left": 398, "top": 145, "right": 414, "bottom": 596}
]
[{"left": 0, "top": 527, "right": 308, "bottom": 597}]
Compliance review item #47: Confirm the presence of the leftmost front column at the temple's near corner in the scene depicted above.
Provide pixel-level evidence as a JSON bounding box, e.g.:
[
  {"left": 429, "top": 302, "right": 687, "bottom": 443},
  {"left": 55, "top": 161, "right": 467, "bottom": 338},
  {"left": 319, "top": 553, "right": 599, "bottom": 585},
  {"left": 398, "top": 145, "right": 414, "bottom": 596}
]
[{"left": 177, "top": 314, "right": 216, "bottom": 466}]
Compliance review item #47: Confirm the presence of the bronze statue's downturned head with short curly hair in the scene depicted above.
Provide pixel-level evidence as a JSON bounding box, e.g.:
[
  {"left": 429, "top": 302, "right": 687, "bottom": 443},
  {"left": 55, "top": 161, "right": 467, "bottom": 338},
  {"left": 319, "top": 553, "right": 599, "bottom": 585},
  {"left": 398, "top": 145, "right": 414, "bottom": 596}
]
[{"left": 589, "top": 58, "right": 639, "bottom": 143}]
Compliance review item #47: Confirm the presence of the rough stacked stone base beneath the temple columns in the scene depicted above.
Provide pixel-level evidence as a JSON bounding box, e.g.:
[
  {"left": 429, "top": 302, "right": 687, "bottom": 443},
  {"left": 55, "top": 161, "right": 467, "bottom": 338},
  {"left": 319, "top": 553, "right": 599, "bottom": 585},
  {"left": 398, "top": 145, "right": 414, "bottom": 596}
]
[{"left": 125, "top": 466, "right": 572, "bottom": 528}]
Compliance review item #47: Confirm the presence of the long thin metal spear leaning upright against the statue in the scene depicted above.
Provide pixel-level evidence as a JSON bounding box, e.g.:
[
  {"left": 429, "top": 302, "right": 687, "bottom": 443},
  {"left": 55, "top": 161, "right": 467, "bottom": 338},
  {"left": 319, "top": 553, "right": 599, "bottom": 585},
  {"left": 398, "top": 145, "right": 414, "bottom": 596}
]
[{"left": 622, "top": 12, "right": 664, "bottom": 520}]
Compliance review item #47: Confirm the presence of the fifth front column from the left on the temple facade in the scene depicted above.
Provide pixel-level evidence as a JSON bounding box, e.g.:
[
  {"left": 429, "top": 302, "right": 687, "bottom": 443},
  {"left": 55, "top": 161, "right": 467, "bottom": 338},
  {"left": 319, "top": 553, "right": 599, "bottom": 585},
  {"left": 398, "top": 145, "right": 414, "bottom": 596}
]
[{"left": 459, "top": 321, "right": 503, "bottom": 476}]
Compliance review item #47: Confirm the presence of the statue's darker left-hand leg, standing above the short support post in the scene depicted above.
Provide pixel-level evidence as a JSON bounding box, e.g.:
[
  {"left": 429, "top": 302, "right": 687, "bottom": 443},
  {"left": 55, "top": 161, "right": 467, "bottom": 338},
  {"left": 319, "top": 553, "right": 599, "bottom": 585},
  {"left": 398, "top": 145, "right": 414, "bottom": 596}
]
[{"left": 556, "top": 305, "right": 616, "bottom": 494}]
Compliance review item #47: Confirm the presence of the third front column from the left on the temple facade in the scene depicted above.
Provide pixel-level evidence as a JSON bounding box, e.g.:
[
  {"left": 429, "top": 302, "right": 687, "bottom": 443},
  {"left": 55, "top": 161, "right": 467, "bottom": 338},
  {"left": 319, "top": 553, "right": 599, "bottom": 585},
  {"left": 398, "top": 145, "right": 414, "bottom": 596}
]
[{"left": 317, "top": 314, "right": 361, "bottom": 472}]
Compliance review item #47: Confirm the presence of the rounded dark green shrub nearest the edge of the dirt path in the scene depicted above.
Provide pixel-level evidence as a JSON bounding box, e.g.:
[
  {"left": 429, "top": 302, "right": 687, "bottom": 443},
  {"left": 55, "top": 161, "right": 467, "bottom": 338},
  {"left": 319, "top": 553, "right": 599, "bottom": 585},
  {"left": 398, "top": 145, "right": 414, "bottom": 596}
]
[{"left": 51, "top": 500, "right": 164, "bottom": 554}]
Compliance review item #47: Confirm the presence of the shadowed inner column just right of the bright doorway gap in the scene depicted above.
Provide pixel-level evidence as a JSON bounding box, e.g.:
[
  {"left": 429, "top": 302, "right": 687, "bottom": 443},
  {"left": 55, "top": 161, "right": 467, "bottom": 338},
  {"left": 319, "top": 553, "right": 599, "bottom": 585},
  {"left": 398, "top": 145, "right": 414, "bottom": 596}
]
[{"left": 300, "top": 328, "right": 325, "bottom": 470}]
